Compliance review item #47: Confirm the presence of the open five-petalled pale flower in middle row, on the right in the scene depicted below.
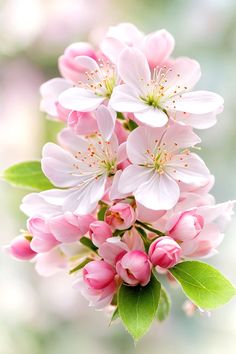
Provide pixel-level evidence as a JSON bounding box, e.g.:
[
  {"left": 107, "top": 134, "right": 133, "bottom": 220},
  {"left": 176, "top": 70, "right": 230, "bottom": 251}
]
[{"left": 118, "top": 124, "right": 209, "bottom": 210}]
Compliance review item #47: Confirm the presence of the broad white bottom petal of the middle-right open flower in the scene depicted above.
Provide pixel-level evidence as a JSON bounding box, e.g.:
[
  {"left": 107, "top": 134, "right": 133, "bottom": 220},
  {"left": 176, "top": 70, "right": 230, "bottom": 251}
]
[{"left": 134, "top": 171, "right": 180, "bottom": 210}]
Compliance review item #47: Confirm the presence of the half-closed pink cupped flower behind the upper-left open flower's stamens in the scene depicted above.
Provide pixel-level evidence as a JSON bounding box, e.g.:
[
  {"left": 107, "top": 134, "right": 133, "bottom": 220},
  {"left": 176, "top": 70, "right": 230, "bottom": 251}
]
[{"left": 58, "top": 42, "right": 97, "bottom": 83}]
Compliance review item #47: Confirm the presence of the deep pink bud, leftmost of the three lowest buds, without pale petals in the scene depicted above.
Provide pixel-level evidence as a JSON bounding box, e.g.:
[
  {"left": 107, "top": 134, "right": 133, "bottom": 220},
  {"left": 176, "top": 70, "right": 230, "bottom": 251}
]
[{"left": 83, "top": 261, "right": 116, "bottom": 290}]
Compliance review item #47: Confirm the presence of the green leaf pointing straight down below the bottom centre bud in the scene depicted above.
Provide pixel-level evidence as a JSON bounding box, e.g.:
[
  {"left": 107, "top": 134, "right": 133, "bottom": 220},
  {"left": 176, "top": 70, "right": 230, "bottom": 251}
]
[{"left": 118, "top": 275, "right": 161, "bottom": 341}]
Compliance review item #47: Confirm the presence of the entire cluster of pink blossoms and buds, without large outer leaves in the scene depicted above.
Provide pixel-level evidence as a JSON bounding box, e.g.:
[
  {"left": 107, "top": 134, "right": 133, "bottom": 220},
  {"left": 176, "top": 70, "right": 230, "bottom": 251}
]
[{"left": 9, "top": 23, "right": 234, "bottom": 314}]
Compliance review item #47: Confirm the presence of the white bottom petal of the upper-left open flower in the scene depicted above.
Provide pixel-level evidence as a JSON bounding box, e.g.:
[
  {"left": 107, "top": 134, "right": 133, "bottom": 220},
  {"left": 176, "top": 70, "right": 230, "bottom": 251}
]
[{"left": 58, "top": 87, "right": 105, "bottom": 112}]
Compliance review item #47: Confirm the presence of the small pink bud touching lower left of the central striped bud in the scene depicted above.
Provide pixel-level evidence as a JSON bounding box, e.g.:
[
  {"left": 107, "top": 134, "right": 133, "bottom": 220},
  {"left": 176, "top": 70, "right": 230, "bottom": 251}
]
[{"left": 89, "top": 220, "right": 112, "bottom": 247}]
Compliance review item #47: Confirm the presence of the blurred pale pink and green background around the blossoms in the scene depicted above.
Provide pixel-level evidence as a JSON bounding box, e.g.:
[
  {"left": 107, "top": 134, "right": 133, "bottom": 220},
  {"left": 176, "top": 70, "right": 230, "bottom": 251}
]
[{"left": 0, "top": 0, "right": 236, "bottom": 354}]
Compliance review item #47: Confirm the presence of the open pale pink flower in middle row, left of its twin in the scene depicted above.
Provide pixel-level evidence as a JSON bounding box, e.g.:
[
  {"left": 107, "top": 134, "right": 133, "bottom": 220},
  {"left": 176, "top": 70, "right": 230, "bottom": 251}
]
[{"left": 42, "top": 129, "right": 123, "bottom": 215}]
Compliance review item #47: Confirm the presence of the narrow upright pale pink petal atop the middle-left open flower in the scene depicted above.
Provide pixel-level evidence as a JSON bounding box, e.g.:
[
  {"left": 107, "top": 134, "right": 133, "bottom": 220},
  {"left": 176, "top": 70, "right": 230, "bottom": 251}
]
[{"left": 95, "top": 105, "right": 116, "bottom": 141}]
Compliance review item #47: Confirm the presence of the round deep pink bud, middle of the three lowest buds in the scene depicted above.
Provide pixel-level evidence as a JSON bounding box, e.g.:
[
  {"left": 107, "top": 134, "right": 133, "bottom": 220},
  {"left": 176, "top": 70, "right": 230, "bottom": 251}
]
[{"left": 116, "top": 251, "right": 151, "bottom": 286}]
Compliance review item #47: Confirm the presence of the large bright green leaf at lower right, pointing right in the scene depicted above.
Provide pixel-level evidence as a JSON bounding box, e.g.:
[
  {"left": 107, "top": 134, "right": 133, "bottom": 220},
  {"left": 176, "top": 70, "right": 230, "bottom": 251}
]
[{"left": 170, "top": 261, "right": 236, "bottom": 309}]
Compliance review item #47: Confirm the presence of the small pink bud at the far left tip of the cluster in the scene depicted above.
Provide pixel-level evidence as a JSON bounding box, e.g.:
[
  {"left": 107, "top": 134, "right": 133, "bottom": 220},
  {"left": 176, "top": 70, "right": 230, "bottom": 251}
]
[{"left": 9, "top": 236, "right": 37, "bottom": 261}]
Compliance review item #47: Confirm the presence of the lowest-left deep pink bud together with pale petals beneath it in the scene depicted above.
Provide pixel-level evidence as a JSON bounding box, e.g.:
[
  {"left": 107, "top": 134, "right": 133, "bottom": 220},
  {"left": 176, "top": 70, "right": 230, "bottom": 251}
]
[{"left": 74, "top": 261, "right": 116, "bottom": 308}]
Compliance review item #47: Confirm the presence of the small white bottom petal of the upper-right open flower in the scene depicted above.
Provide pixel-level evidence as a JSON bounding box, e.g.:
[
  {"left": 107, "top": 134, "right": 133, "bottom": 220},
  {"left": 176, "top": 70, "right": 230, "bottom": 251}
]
[{"left": 135, "top": 105, "right": 168, "bottom": 127}]
